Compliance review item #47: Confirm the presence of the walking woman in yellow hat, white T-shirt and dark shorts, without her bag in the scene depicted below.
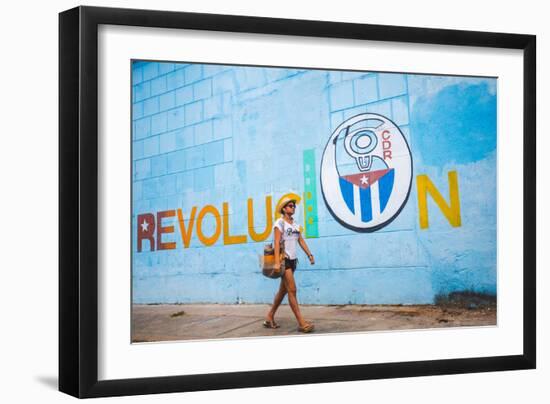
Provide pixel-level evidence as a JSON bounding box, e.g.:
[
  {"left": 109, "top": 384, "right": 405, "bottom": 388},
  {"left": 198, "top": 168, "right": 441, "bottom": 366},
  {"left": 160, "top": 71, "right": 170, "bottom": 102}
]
[{"left": 264, "top": 197, "right": 315, "bottom": 333}]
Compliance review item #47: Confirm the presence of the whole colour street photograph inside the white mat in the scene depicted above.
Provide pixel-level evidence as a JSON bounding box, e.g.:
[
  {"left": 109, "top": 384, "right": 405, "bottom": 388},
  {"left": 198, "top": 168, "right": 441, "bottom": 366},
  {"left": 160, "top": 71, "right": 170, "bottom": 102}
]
[{"left": 130, "top": 60, "right": 497, "bottom": 342}]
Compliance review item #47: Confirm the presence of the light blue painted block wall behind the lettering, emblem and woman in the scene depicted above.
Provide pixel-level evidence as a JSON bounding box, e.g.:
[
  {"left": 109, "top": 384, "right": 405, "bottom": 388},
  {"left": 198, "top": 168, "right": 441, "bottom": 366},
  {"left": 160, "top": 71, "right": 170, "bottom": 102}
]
[{"left": 132, "top": 62, "right": 496, "bottom": 304}]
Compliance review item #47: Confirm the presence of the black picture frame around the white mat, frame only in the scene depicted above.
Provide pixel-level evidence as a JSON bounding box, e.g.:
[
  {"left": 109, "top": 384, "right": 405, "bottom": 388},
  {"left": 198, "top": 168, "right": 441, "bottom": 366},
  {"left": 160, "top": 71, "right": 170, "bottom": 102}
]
[{"left": 59, "top": 7, "right": 536, "bottom": 398}]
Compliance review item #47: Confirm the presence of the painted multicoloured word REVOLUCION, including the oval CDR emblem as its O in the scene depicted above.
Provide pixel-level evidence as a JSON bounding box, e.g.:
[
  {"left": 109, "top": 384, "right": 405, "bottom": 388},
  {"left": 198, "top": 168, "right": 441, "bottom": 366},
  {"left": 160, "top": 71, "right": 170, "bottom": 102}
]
[{"left": 136, "top": 113, "right": 461, "bottom": 252}]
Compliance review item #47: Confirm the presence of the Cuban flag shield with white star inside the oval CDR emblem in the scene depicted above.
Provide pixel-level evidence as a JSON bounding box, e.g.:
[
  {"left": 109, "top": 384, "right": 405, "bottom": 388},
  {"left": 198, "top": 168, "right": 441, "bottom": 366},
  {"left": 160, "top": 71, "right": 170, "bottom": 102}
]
[{"left": 339, "top": 168, "right": 394, "bottom": 222}]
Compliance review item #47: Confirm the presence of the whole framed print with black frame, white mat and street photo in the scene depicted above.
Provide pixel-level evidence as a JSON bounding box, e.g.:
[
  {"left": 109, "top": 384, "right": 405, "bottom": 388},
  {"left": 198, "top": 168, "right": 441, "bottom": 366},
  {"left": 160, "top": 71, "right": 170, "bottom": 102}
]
[{"left": 59, "top": 7, "right": 536, "bottom": 397}]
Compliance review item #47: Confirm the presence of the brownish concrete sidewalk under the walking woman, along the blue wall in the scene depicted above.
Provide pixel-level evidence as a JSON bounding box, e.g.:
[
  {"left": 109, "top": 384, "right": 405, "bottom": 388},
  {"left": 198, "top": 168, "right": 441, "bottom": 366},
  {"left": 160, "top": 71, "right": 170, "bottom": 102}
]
[{"left": 132, "top": 304, "right": 496, "bottom": 342}]
